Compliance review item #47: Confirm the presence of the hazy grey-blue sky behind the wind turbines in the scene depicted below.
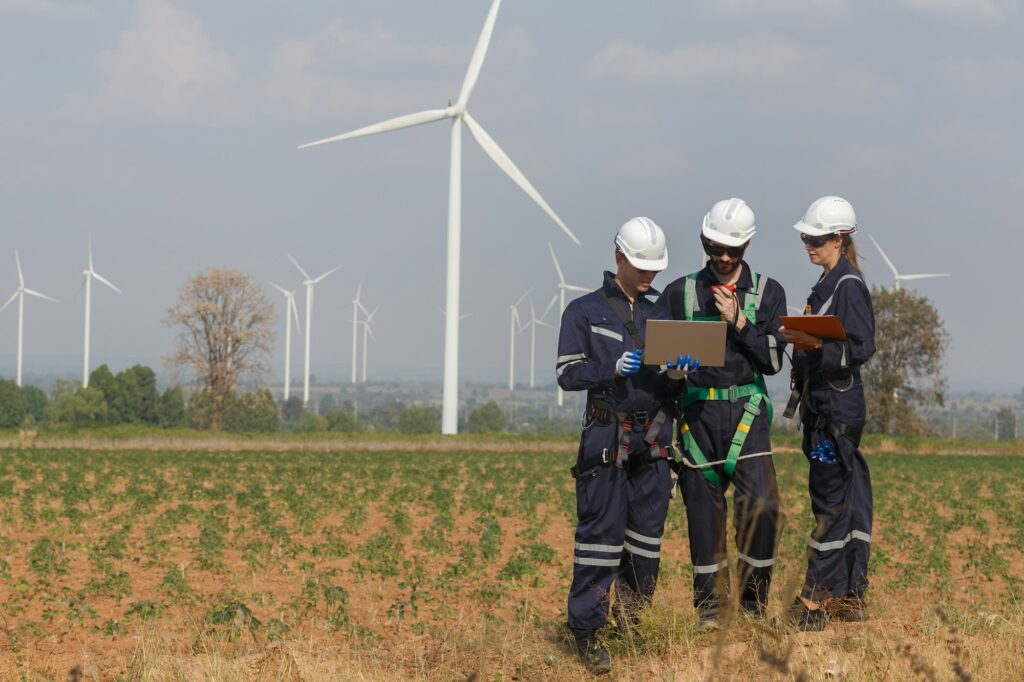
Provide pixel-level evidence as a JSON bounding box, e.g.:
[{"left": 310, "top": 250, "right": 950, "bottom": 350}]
[{"left": 0, "top": 0, "right": 1024, "bottom": 391}]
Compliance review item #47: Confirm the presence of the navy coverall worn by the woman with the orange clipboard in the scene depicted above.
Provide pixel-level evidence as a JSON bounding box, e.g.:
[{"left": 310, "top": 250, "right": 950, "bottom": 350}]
[{"left": 793, "top": 257, "right": 874, "bottom": 601}]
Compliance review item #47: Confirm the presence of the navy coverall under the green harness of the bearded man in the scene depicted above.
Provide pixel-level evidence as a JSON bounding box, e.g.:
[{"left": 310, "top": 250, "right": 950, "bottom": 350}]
[{"left": 658, "top": 261, "right": 785, "bottom": 615}]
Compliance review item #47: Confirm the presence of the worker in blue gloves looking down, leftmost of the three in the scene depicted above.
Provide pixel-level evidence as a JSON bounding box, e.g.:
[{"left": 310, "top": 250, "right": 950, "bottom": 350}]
[{"left": 556, "top": 218, "right": 695, "bottom": 673}]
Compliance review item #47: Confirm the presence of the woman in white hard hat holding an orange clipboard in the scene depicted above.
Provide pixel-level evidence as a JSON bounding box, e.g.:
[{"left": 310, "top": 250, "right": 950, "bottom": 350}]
[{"left": 780, "top": 197, "right": 874, "bottom": 630}]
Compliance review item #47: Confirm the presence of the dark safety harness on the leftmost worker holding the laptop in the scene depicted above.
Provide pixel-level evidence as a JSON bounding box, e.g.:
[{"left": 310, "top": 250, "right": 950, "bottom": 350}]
[{"left": 569, "top": 288, "right": 671, "bottom": 478}]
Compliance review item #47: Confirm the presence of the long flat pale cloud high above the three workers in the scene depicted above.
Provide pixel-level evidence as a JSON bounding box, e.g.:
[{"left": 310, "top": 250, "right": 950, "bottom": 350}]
[{"left": 587, "top": 35, "right": 814, "bottom": 85}]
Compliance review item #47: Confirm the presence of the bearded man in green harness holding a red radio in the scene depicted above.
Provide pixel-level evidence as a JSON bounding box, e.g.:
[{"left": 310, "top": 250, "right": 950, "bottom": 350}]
[{"left": 658, "top": 198, "right": 785, "bottom": 628}]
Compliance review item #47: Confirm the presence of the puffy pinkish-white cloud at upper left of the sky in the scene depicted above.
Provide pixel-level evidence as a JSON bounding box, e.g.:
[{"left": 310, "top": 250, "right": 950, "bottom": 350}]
[{"left": 97, "top": 0, "right": 238, "bottom": 120}]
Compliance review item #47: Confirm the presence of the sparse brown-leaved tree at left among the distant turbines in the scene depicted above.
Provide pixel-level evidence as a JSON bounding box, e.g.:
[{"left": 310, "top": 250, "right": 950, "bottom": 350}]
[{"left": 164, "top": 268, "right": 276, "bottom": 431}]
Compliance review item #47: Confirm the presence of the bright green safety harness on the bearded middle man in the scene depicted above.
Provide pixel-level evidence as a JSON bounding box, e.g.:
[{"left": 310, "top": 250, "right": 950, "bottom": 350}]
[{"left": 679, "top": 271, "right": 772, "bottom": 487}]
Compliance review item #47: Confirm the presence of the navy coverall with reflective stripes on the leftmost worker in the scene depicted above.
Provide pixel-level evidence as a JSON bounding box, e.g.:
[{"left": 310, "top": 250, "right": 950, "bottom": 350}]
[{"left": 556, "top": 272, "right": 673, "bottom": 630}]
